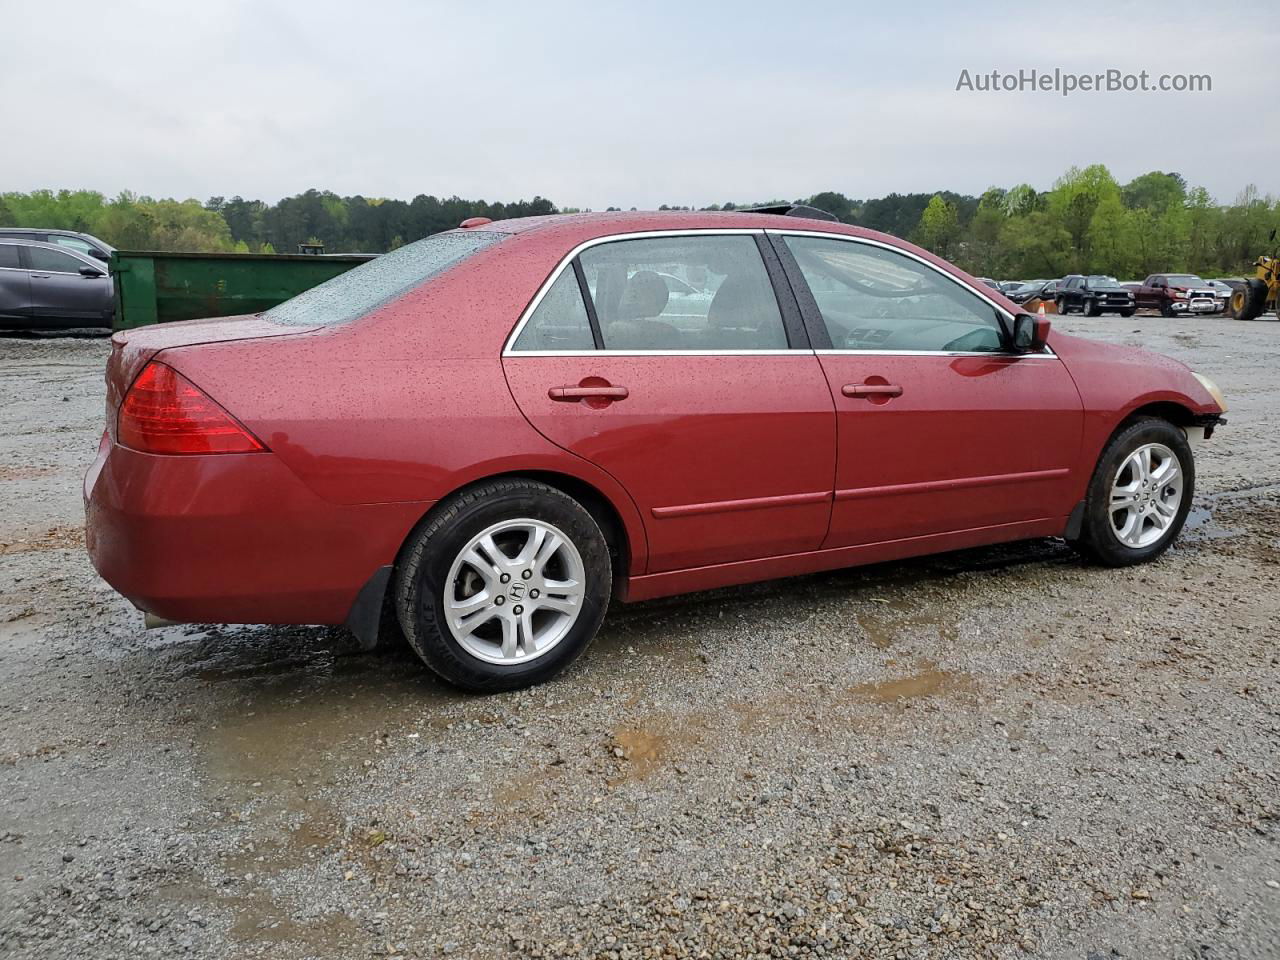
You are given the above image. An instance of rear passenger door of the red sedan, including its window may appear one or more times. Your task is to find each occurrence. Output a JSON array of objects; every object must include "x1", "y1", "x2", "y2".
[{"x1": 503, "y1": 230, "x2": 836, "y2": 572}]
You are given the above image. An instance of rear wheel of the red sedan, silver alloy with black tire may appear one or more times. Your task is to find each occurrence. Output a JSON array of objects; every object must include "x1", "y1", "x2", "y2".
[{"x1": 396, "y1": 479, "x2": 613, "y2": 692}]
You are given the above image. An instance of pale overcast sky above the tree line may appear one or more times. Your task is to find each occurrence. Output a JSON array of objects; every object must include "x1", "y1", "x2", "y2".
[{"x1": 0, "y1": 0, "x2": 1280, "y2": 209}]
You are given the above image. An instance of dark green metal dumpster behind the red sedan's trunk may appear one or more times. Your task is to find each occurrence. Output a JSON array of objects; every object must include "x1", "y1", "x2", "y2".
[{"x1": 111, "y1": 250, "x2": 374, "y2": 330}]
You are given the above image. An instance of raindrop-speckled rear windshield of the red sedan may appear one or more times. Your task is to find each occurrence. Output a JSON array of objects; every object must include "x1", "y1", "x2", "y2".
[{"x1": 262, "y1": 230, "x2": 507, "y2": 326}]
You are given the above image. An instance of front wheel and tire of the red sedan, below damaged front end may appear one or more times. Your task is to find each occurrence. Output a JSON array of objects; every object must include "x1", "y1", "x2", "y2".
[{"x1": 1074, "y1": 417, "x2": 1196, "y2": 567}]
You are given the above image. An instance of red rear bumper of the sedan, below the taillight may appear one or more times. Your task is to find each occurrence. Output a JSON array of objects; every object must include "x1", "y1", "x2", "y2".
[{"x1": 84, "y1": 438, "x2": 431, "y2": 632}]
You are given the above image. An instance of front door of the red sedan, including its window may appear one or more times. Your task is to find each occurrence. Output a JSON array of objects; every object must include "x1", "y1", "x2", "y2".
[{"x1": 776, "y1": 232, "x2": 1083, "y2": 547}]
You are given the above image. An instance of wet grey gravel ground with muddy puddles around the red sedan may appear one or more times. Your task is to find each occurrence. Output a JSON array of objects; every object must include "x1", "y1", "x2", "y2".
[{"x1": 0, "y1": 317, "x2": 1280, "y2": 960}]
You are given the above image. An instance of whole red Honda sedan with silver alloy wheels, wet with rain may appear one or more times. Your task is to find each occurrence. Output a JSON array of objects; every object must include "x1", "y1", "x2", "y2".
[{"x1": 84, "y1": 211, "x2": 1226, "y2": 690}]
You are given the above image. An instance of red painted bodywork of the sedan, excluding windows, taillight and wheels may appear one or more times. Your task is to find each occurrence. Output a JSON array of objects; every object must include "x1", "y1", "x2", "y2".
[{"x1": 84, "y1": 212, "x2": 1216, "y2": 623}]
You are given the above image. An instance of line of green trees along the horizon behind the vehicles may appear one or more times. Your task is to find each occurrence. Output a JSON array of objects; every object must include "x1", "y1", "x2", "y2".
[{"x1": 0, "y1": 164, "x2": 1280, "y2": 279}]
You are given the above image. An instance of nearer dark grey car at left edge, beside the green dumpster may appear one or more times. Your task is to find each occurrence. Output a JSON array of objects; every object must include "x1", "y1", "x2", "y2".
[{"x1": 0, "y1": 236, "x2": 115, "y2": 329}]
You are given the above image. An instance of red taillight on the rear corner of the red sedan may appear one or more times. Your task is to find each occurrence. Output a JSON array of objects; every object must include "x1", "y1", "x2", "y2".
[{"x1": 115, "y1": 361, "x2": 266, "y2": 453}]
